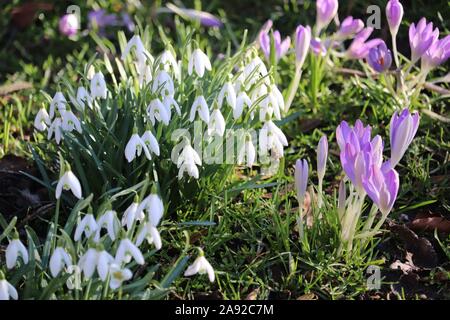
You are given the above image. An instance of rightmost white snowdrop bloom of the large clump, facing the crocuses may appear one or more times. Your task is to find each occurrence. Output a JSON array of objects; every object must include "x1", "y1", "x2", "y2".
[{"x1": 259, "y1": 120, "x2": 288, "y2": 159}]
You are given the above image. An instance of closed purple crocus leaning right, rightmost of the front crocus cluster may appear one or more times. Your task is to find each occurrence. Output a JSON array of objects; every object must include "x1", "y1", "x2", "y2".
[{"x1": 389, "y1": 109, "x2": 420, "y2": 168}]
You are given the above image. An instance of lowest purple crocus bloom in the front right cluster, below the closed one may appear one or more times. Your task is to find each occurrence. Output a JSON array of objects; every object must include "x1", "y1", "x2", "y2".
[{"x1": 363, "y1": 165, "x2": 400, "y2": 216}]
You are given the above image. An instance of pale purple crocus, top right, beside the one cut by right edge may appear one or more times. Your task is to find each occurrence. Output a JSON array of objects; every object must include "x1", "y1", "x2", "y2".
[{"x1": 409, "y1": 18, "x2": 439, "y2": 63}]
